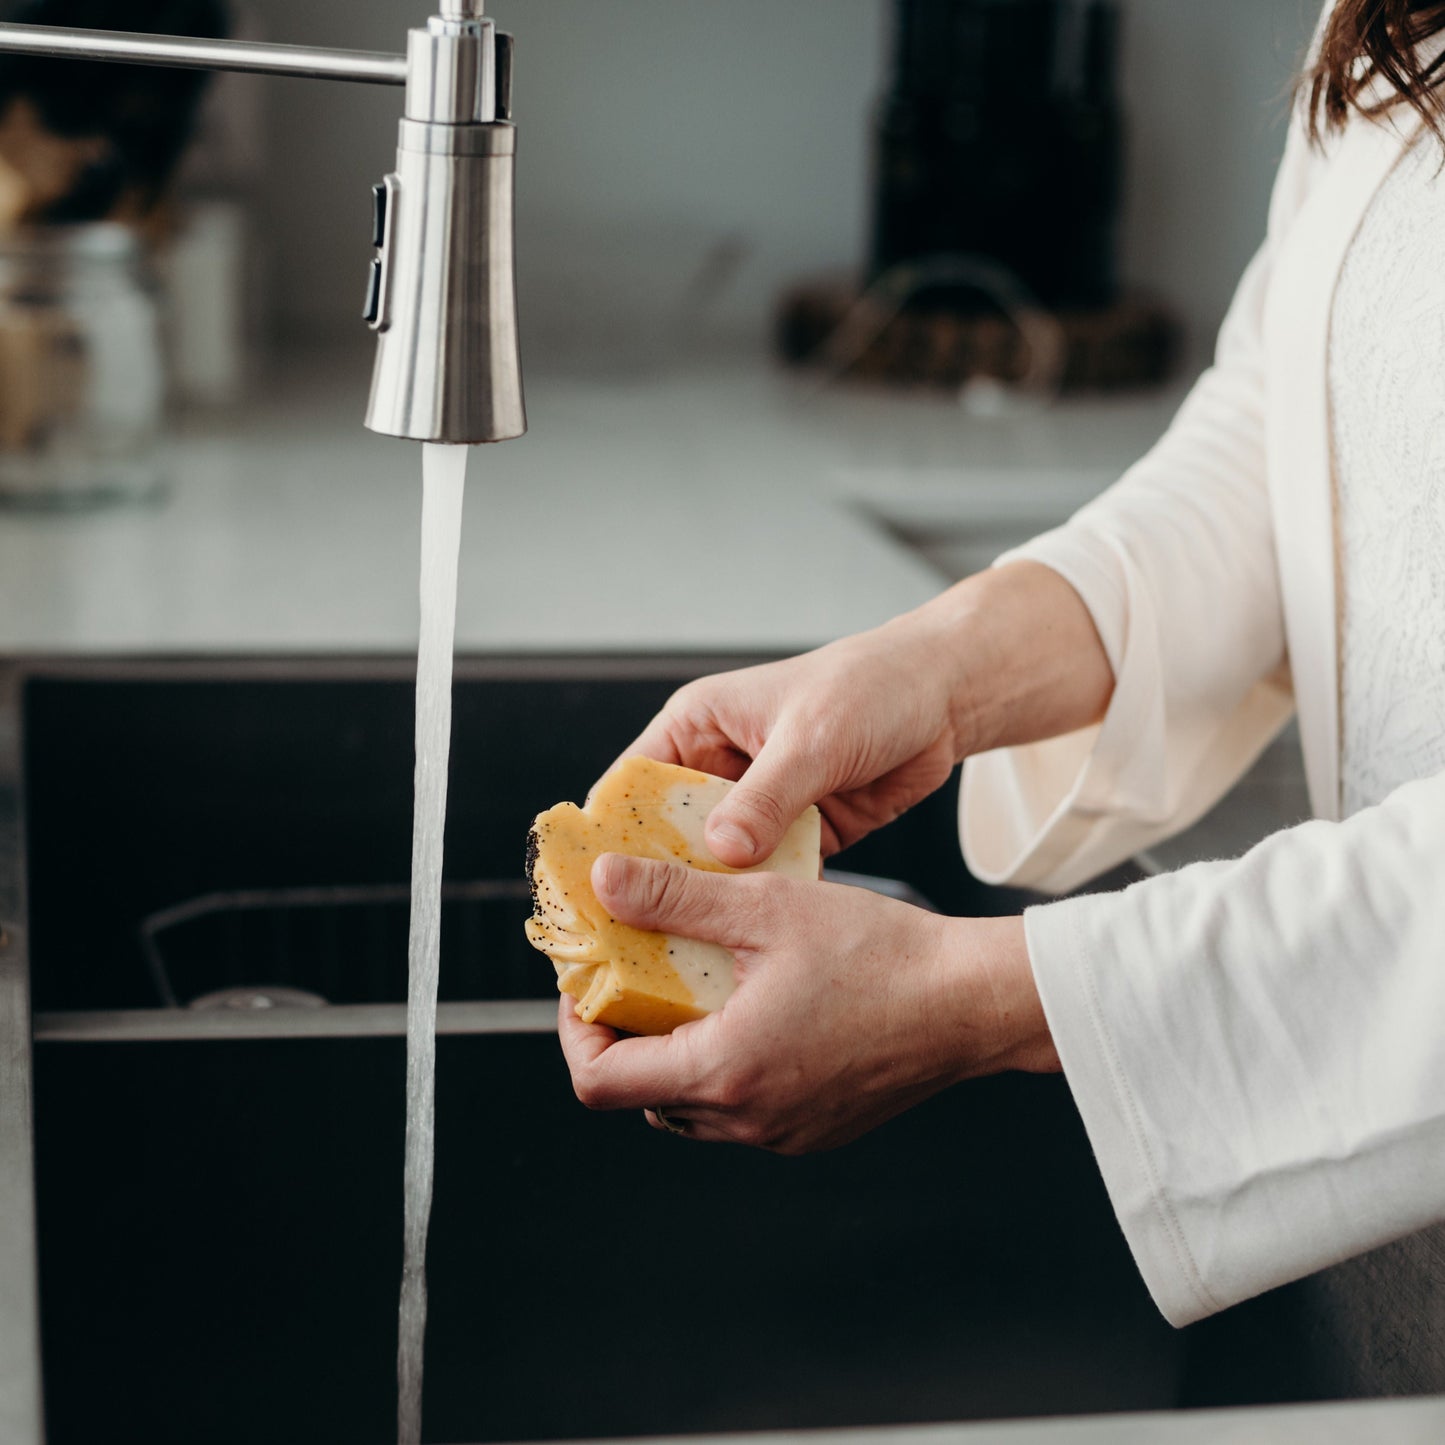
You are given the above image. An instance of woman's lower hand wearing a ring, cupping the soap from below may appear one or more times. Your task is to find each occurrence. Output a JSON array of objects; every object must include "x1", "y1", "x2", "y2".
[{"x1": 559, "y1": 854, "x2": 1059, "y2": 1155}]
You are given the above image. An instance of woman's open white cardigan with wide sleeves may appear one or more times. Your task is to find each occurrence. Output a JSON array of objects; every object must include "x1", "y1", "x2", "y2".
[{"x1": 961, "y1": 36, "x2": 1445, "y2": 1324}]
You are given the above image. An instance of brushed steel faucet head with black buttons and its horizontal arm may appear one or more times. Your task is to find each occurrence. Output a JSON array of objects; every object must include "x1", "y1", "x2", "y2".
[{"x1": 0, "y1": 0, "x2": 527, "y2": 444}]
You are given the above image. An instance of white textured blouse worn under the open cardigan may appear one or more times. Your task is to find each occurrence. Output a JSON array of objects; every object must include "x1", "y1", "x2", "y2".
[{"x1": 1329, "y1": 134, "x2": 1445, "y2": 818}]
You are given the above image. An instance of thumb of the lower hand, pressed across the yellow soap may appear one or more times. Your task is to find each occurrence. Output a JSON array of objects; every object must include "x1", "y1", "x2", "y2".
[{"x1": 592, "y1": 853, "x2": 762, "y2": 948}]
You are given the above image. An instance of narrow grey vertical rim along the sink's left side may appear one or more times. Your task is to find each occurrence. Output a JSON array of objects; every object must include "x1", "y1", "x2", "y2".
[{"x1": 0, "y1": 669, "x2": 43, "y2": 1445}]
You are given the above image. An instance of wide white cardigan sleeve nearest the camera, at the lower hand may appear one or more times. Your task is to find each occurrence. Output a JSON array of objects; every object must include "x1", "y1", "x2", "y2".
[{"x1": 1026, "y1": 775, "x2": 1445, "y2": 1325}]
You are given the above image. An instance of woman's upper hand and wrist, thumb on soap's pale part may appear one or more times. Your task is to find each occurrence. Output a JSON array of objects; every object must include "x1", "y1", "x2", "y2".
[{"x1": 624, "y1": 562, "x2": 1113, "y2": 868}]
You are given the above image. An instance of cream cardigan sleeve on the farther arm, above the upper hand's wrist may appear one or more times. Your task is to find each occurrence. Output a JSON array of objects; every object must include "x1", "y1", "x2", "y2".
[{"x1": 959, "y1": 124, "x2": 1318, "y2": 893}]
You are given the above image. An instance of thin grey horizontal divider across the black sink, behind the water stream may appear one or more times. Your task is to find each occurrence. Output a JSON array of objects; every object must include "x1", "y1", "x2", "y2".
[{"x1": 35, "y1": 998, "x2": 556, "y2": 1040}]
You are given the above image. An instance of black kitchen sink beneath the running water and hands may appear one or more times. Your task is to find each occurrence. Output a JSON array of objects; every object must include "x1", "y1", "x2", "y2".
[{"x1": 0, "y1": 657, "x2": 1306, "y2": 1445}]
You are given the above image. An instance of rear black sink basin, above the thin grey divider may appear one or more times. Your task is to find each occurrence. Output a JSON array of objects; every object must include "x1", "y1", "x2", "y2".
[{"x1": 23, "y1": 659, "x2": 988, "y2": 1013}]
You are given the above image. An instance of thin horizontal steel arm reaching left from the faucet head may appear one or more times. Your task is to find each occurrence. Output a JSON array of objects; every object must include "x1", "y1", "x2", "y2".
[{"x1": 0, "y1": 25, "x2": 406, "y2": 85}]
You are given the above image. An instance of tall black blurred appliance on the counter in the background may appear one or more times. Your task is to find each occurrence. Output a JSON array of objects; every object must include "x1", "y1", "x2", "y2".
[{"x1": 868, "y1": 0, "x2": 1123, "y2": 311}]
